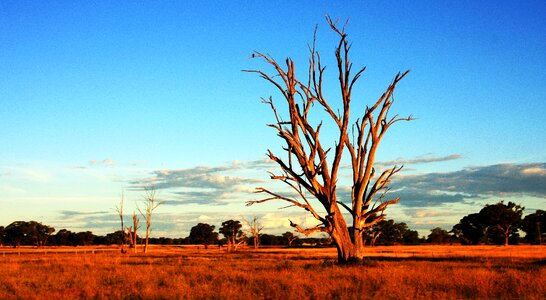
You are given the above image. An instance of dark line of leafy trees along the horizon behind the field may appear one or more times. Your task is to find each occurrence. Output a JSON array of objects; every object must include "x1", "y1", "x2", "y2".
[{"x1": 0, "y1": 201, "x2": 546, "y2": 251}]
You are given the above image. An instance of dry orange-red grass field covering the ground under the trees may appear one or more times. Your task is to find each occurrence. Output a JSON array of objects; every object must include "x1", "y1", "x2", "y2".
[{"x1": 0, "y1": 246, "x2": 546, "y2": 299}]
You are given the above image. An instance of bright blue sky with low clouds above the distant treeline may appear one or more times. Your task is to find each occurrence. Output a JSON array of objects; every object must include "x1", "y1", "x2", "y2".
[{"x1": 0, "y1": 1, "x2": 546, "y2": 236}]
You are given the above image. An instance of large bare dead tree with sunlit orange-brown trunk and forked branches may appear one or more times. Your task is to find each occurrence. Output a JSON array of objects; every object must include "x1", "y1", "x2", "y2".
[{"x1": 245, "y1": 17, "x2": 412, "y2": 263}]
